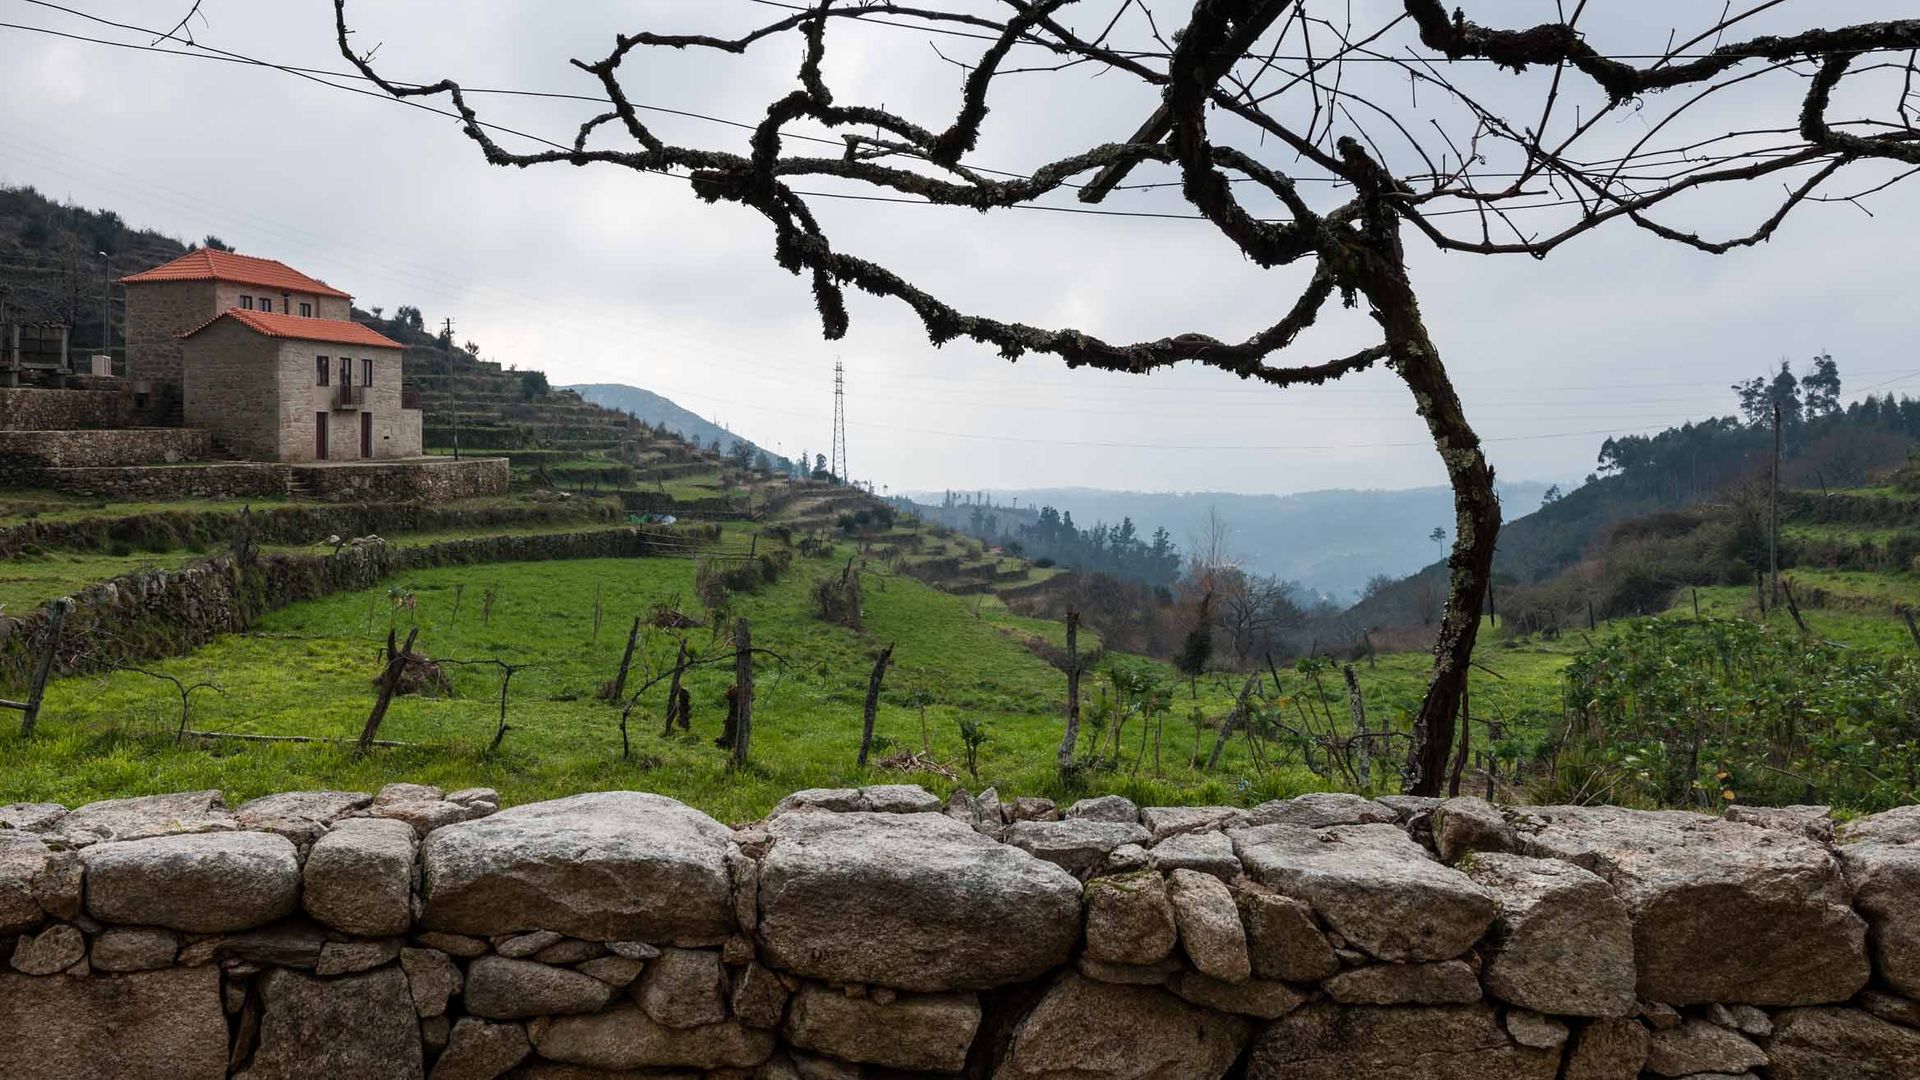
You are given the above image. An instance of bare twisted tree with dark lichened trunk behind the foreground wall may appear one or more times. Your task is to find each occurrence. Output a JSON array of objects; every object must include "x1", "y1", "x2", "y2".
[{"x1": 334, "y1": 0, "x2": 1920, "y2": 794}]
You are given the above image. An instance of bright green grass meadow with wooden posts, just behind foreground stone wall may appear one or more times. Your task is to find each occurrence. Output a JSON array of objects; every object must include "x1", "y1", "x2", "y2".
[{"x1": 0, "y1": 541, "x2": 1419, "y2": 821}]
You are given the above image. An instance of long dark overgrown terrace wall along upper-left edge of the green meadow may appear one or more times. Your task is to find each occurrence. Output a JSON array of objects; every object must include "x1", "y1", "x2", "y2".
[{"x1": 0, "y1": 525, "x2": 714, "y2": 672}]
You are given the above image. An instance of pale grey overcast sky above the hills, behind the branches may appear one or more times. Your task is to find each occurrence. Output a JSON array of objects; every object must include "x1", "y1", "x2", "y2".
[{"x1": 0, "y1": 0, "x2": 1920, "y2": 492}]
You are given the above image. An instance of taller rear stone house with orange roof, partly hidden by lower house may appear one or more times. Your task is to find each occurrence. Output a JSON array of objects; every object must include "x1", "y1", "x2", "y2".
[{"x1": 119, "y1": 248, "x2": 355, "y2": 423}]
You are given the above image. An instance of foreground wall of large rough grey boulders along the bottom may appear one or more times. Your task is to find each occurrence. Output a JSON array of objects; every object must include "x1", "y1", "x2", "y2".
[{"x1": 0, "y1": 784, "x2": 1920, "y2": 1080}]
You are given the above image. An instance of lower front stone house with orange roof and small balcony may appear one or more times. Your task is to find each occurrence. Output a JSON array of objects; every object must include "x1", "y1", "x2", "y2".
[{"x1": 179, "y1": 311, "x2": 420, "y2": 461}]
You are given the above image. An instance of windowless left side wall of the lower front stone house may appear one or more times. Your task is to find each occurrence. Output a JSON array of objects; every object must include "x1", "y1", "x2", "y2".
[{"x1": 180, "y1": 319, "x2": 284, "y2": 461}]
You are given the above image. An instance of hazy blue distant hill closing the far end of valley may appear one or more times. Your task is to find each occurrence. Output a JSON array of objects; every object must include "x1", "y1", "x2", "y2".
[{"x1": 914, "y1": 482, "x2": 1548, "y2": 601}]
